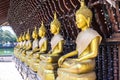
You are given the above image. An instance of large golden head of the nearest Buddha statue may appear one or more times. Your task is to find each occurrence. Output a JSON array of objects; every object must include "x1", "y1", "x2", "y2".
[{"x1": 75, "y1": 0, "x2": 92, "y2": 29}]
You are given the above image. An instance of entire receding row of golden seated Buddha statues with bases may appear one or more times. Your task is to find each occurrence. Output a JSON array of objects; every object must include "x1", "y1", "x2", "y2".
[{"x1": 14, "y1": 0, "x2": 102, "y2": 80}]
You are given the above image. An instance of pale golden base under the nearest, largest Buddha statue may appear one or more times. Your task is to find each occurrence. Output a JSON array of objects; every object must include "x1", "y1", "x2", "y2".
[{"x1": 56, "y1": 70, "x2": 96, "y2": 80}]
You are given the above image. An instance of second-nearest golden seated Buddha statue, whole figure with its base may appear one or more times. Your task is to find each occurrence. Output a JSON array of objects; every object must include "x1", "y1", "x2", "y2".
[{"x1": 38, "y1": 13, "x2": 64, "y2": 80}]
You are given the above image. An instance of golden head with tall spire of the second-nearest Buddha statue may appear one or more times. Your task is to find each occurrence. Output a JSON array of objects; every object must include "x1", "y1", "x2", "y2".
[{"x1": 50, "y1": 13, "x2": 61, "y2": 34}]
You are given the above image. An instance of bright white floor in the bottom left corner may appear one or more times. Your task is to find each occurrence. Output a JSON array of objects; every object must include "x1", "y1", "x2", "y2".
[{"x1": 0, "y1": 62, "x2": 23, "y2": 80}]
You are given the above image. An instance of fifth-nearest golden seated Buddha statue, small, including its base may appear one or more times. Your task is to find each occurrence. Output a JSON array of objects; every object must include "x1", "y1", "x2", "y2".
[{"x1": 21, "y1": 29, "x2": 32, "y2": 62}]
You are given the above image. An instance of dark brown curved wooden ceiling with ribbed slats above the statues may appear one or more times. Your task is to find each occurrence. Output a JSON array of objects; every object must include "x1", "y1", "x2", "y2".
[{"x1": 0, "y1": 0, "x2": 120, "y2": 40}]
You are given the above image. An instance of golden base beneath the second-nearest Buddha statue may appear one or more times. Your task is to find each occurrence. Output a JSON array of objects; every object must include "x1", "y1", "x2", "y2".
[{"x1": 37, "y1": 61, "x2": 58, "y2": 80}]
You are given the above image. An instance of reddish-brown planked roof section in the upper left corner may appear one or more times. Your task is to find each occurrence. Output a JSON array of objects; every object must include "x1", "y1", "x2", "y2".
[{"x1": 0, "y1": 0, "x2": 10, "y2": 25}]
